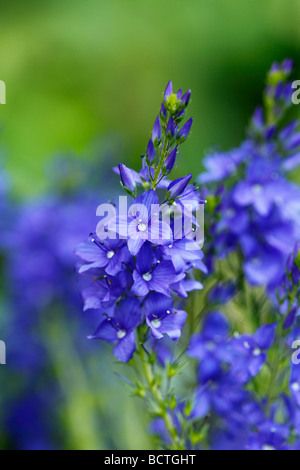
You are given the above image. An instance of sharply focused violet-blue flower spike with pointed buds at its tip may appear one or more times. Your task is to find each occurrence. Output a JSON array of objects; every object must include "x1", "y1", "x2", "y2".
[{"x1": 76, "y1": 82, "x2": 206, "y2": 362}]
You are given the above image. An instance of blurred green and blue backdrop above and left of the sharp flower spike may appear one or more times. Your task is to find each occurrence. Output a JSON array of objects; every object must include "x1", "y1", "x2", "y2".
[{"x1": 0, "y1": 0, "x2": 300, "y2": 449}]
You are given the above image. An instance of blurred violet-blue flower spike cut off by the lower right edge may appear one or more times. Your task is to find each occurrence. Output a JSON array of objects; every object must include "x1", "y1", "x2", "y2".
[{"x1": 240, "y1": 244, "x2": 300, "y2": 450}]
